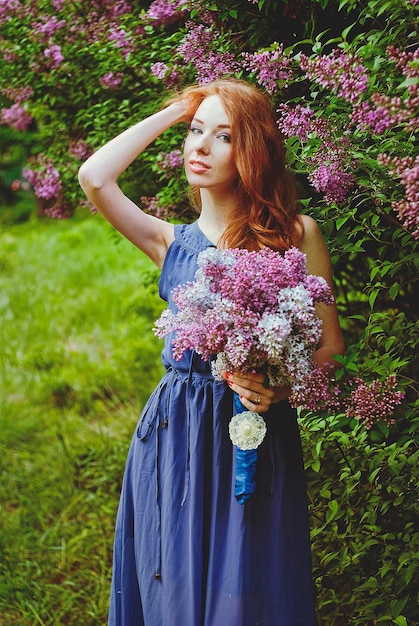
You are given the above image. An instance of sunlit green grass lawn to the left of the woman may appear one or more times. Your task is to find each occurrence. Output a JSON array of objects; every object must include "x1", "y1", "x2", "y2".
[{"x1": 0, "y1": 216, "x2": 167, "y2": 626}]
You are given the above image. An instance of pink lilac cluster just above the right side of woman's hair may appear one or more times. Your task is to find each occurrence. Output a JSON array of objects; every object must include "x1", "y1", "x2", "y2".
[{"x1": 242, "y1": 44, "x2": 293, "y2": 94}]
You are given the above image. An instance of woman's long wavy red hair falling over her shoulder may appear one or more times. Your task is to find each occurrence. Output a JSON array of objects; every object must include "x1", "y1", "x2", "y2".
[{"x1": 169, "y1": 79, "x2": 302, "y2": 252}]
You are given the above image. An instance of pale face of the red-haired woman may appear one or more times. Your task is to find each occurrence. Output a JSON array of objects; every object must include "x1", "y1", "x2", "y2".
[{"x1": 184, "y1": 96, "x2": 238, "y2": 189}]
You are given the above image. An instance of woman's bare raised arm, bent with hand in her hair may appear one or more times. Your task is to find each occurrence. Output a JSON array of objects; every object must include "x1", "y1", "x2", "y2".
[{"x1": 79, "y1": 100, "x2": 187, "y2": 267}]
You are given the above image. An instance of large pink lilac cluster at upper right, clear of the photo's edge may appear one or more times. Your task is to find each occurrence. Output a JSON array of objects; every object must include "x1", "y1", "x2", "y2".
[{"x1": 300, "y1": 50, "x2": 369, "y2": 103}]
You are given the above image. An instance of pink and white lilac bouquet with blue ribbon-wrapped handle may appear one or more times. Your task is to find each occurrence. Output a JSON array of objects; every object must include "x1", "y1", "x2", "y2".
[{"x1": 154, "y1": 248, "x2": 333, "y2": 504}]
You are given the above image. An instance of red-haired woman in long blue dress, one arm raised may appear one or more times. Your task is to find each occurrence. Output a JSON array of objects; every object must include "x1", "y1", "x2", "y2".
[{"x1": 79, "y1": 80, "x2": 344, "y2": 626}]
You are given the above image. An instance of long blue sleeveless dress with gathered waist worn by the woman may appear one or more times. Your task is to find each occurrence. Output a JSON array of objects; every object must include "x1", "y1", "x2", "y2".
[{"x1": 109, "y1": 222, "x2": 315, "y2": 626}]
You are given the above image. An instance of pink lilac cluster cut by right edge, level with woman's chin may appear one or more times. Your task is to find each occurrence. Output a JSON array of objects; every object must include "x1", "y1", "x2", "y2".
[{"x1": 377, "y1": 154, "x2": 419, "y2": 239}]
